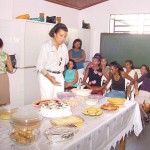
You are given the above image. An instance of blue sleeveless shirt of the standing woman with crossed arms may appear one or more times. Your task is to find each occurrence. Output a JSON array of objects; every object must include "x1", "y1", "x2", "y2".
[{"x1": 72, "y1": 49, "x2": 84, "y2": 69}]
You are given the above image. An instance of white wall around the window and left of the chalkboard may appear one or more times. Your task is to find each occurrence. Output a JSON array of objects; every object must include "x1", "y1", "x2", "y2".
[{"x1": 79, "y1": 0, "x2": 150, "y2": 54}]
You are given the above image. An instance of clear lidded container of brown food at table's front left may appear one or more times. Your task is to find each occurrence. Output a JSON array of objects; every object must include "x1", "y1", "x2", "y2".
[{"x1": 9, "y1": 110, "x2": 42, "y2": 145}]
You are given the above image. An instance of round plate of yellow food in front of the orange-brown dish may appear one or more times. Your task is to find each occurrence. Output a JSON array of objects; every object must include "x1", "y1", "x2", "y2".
[{"x1": 82, "y1": 106, "x2": 103, "y2": 116}]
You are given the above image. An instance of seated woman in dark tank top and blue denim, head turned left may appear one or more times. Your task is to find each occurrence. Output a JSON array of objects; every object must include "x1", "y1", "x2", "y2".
[{"x1": 102, "y1": 61, "x2": 134, "y2": 98}]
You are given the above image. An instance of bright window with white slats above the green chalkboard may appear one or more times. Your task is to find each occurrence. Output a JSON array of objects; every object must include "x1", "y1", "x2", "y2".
[{"x1": 110, "y1": 14, "x2": 150, "y2": 34}]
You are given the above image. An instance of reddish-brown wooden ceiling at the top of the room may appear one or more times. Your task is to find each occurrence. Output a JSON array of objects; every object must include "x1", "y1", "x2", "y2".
[{"x1": 46, "y1": 0, "x2": 108, "y2": 10}]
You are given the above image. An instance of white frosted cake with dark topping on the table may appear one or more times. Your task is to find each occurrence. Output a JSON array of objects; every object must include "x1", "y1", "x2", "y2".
[{"x1": 40, "y1": 100, "x2": 72, "y2": 118}]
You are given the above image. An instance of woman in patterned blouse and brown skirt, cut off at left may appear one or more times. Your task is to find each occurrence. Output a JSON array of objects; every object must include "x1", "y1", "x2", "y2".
[{"x1": 0, "y1": 38, "x2": 13, "y2": 105}]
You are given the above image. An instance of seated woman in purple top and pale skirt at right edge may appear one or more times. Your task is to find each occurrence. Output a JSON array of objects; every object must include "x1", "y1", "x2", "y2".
[{"x1": 135, "y1": 72, "x2": 150, "y2": 119}]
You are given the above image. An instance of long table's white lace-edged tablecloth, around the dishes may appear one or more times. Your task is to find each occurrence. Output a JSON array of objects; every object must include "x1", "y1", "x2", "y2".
[{"x1": 0, "y1": 98, "x2": 142, "y2": 150}]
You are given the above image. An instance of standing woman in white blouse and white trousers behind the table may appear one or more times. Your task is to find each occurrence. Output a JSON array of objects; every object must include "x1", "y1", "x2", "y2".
[{"x1": 36, "y1": 23, "x2": 69, "y2": 99}]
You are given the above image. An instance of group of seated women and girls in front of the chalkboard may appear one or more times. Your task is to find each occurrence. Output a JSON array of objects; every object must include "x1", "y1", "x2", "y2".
[{"x1": 64, "y1": 54, "x2": 150, "y2": 122}]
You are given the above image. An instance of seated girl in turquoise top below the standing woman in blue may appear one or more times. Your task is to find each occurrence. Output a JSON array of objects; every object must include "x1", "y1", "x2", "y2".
[{"x1": 64, "y1": 59, "x2": 78, "y2": 91}]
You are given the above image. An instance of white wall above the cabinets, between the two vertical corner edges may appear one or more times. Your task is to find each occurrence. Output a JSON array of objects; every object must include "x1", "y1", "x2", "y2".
[{"x1": 13, "y1": 0, "x2": 79, "y2": 27}]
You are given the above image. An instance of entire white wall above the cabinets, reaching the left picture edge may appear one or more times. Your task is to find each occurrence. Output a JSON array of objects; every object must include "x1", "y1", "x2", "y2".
[{"x1": 0, "y1": 0, "x2": 79, "y2": 27}]
